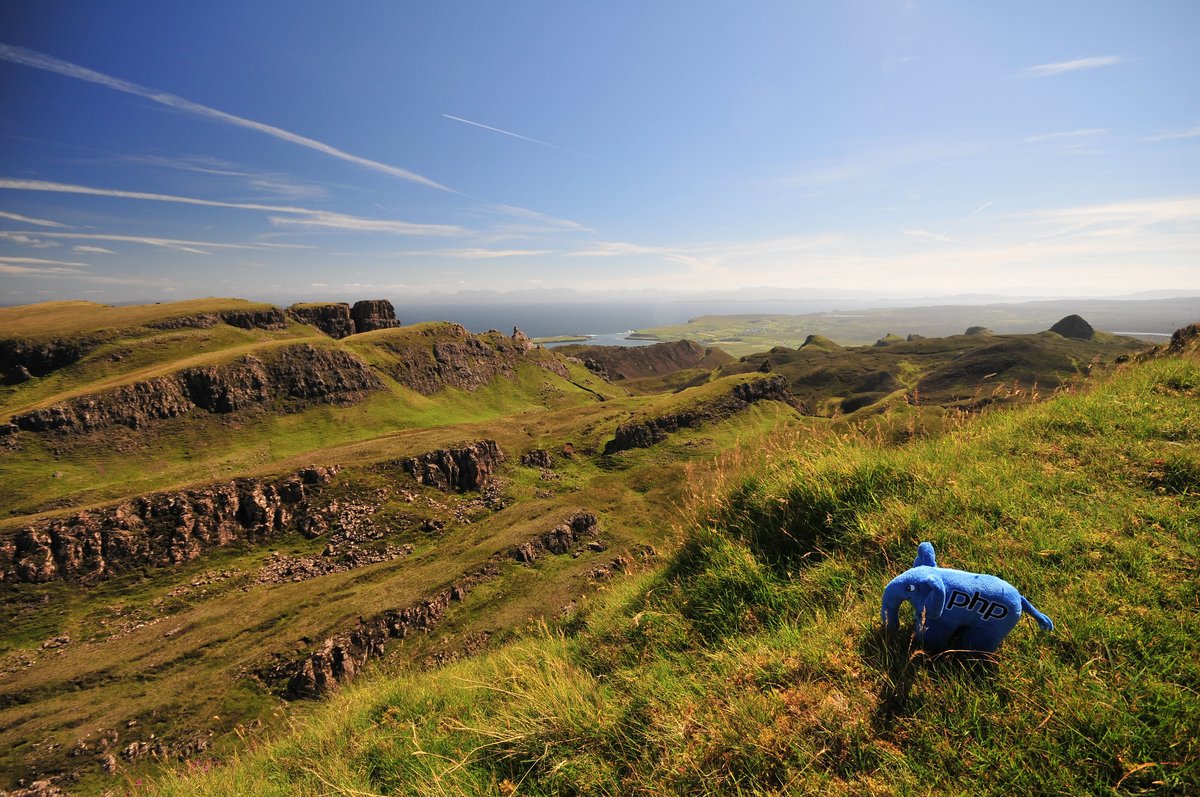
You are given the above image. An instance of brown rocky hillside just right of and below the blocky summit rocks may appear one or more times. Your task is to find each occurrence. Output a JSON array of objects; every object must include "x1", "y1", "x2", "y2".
[{"x1": 378, "y1": 324, "x2": 569, "y2": 396}]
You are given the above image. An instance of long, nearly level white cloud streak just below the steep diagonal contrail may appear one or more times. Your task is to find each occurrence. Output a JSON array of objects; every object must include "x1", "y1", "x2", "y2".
[{"x1": 0, "y1": 178, "x2": 467, "y2": 238}]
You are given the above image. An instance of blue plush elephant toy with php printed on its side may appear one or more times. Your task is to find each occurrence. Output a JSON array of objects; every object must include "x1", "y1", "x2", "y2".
[{"x1": 882, "y1": 543, "x2": 1054, "y2": 653}]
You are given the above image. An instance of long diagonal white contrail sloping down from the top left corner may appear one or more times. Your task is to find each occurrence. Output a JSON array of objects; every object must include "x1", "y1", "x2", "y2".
[{"x1": 0, "y1": 44, "x2": 450, "y2": 191}]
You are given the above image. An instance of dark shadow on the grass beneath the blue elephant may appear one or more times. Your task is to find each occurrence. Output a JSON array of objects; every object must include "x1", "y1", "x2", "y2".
[{"x1": 859, "y1": 625, "x2": 1000, "y2": 731}]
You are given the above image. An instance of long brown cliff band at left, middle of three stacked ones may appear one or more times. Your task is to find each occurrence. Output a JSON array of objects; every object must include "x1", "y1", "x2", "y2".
[{"x1": 8, "y1": 343, "x2": 382, "y2": 433}]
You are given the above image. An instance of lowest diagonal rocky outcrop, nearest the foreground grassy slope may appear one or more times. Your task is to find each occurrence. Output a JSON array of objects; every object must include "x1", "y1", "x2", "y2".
[{"x1": 267, "y1": 511, "x2": 599, "y2": 697}]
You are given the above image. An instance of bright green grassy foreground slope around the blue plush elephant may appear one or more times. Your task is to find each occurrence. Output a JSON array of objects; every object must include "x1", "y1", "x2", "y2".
[{"x1": 151, "y1": 355, "x2": 1200, "y2": 795}]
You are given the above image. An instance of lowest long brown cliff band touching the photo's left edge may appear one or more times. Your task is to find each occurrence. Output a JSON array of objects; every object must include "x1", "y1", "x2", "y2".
[{"x1": 0, "y1": 467, "x2": 337, "y2": 582}]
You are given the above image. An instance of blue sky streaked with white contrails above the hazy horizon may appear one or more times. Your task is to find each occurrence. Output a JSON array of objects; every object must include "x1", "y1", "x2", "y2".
[{"x1": 0, "y1": 0, "x2": 1200, "y2": 302}]
